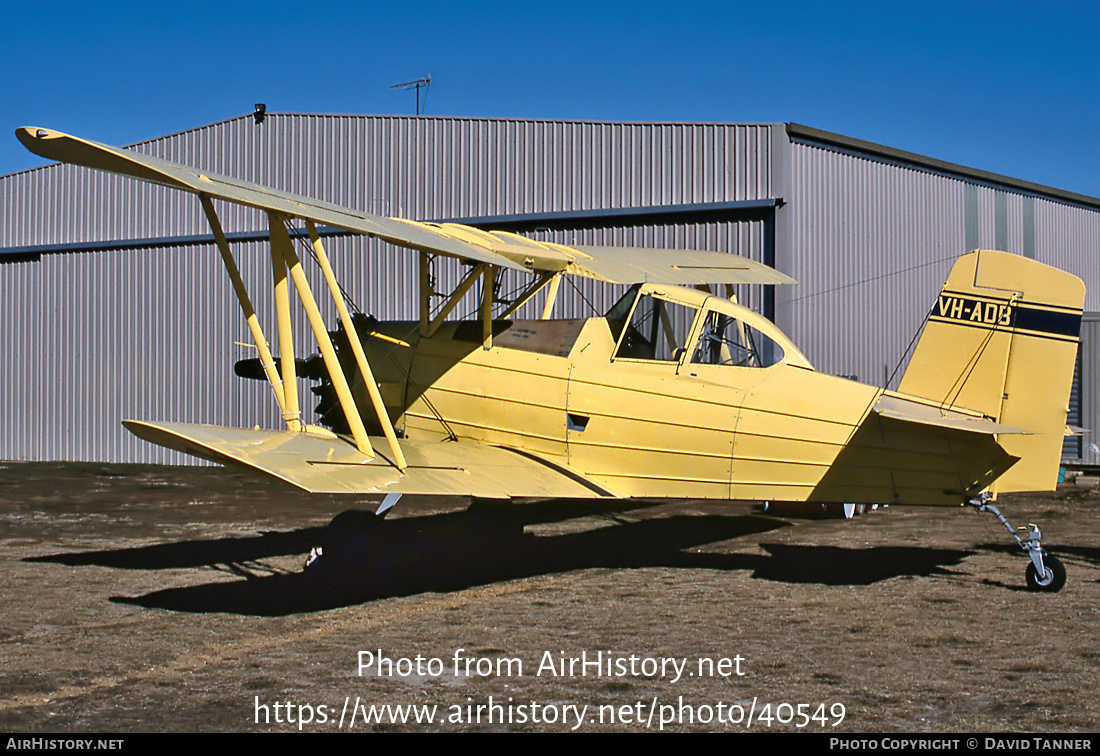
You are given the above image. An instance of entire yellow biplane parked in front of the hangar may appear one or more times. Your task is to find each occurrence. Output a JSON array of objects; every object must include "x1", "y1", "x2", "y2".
[{"x1": 17, "y1": 128, "x2": 1085, "y2": 591}]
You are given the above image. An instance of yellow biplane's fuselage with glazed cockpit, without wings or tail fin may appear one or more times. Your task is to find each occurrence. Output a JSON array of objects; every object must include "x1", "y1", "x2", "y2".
[{"x1": 327, "y1": 286, "x2": 996, "y2": 504}]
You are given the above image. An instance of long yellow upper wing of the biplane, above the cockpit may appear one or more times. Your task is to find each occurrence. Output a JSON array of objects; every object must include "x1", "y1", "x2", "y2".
[{"x1": 15, "y1": 128, "x2": 794, "y2": 285}]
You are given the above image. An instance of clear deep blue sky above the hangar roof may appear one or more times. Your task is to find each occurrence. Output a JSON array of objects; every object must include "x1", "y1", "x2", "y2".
[{"x1": 8, "y1": 0, "x2": 1100, "y2": 196}]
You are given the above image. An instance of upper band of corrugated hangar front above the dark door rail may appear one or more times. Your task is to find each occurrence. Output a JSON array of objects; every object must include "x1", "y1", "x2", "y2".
[{"x1": 0, "y1": 113, "x2": 782, "y2": 248}]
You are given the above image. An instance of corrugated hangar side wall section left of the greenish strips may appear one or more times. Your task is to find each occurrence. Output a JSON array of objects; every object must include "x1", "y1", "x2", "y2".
[{"x1": 776, "y1": 143, "x2": 965, "y2": 388}]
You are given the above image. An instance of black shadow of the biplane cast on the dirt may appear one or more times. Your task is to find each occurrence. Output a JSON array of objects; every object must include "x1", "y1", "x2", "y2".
[{"x1": 31, "y1": 501, "x2": 971, "y2": 616}]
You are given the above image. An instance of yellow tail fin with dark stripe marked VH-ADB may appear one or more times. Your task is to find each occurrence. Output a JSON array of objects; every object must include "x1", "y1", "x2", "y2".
[{"x1": 898, "y1": 250, "x2": 1085, "y2": 493}]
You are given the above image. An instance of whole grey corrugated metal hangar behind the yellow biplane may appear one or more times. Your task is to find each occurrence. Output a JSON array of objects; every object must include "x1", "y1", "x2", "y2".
[{"x1": 0, "y1": 113, "x2": 1100, "y2": 464}]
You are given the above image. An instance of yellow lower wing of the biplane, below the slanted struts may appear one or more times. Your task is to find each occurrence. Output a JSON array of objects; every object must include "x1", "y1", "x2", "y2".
[{"x1": 123, "y1": 420, "x2": 618, "y2": 498}]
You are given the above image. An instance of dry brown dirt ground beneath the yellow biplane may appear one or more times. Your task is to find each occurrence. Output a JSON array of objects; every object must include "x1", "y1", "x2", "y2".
[{"x1": 0, "y1": 463, "x2": 1100, "y2": 733}]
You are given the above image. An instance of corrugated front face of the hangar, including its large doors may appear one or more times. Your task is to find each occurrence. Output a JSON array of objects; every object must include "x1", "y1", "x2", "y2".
[{"x1": 0, "y1": 113, "x2": 782, "y2": 464}]
